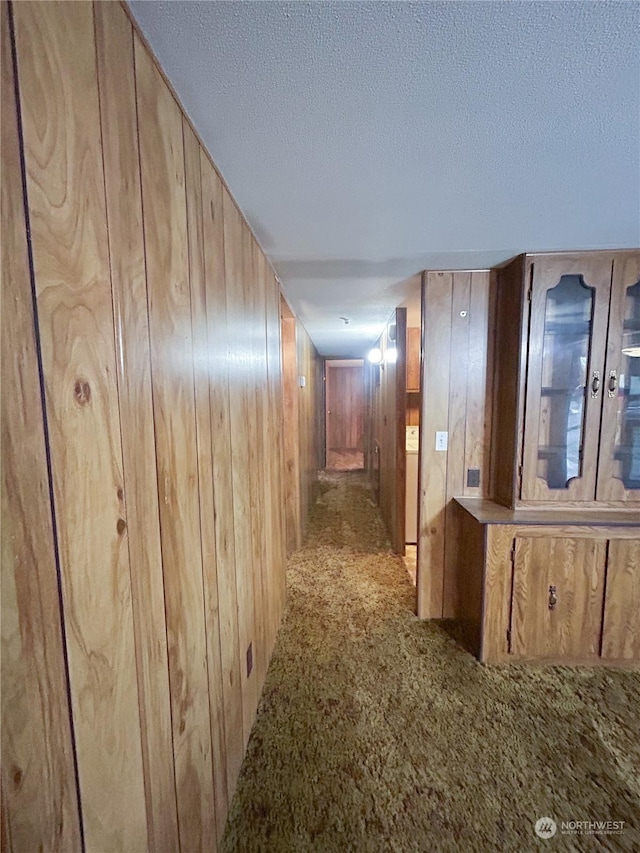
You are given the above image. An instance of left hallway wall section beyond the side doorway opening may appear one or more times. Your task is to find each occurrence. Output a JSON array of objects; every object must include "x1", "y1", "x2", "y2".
[{"x1": 280, "y1": 297, "x2": 324, "y2": 554}]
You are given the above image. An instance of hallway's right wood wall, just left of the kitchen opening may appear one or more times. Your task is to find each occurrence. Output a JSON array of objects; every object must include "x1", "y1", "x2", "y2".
[{"x1": 364, "y1": 308, "x2": 407, "y2": 554}]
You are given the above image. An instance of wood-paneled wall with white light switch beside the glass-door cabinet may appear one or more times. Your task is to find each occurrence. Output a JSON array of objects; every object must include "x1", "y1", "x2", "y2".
[{"x1": 417, "y1": 271, "x2": 495, "y2": 619}]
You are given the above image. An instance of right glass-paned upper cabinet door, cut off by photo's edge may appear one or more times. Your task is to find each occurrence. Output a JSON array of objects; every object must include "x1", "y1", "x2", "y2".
[{"x1": 597, "y1": 252, "x2": 640, "y2": 502}]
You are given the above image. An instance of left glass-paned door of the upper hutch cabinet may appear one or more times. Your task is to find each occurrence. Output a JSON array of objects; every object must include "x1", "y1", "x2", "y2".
[{"x1": 521, "y1": 254, "x2": 613, "y2": 501}]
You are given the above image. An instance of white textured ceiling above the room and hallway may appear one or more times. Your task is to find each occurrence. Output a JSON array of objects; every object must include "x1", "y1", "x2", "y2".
[{"x1": 130, "y1": 0, "x2": 640, "y2": 356}]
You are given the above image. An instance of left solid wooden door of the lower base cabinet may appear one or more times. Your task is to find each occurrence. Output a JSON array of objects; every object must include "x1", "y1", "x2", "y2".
[{"x1": 509, "y1": 534, "x2": 607, "y2": 659}]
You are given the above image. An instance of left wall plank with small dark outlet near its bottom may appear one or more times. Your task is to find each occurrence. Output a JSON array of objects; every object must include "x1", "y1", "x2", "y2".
[{"x1": 222, "y1": 185, "x2": 258, "y2": 746}]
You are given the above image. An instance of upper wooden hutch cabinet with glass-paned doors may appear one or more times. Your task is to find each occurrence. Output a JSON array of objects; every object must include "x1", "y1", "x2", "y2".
[{"x1": 493, "y1": 252, "x2": 640, "y2": 507}]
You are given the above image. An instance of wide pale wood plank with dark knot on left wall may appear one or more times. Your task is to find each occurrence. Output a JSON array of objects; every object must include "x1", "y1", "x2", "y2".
[{"x1": 14, "y1": 3, "x2": 148, "y2": 851}]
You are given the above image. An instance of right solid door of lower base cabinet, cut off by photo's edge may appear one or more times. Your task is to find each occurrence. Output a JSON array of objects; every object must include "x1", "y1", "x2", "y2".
[{"x1": 602, "y1": 539, "x2": 640, "y2": 661}]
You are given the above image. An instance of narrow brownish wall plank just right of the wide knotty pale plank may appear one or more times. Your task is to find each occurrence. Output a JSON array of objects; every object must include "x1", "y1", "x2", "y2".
[{"x1": 94, "y1": 3, "x2": 178, "y2": 851}]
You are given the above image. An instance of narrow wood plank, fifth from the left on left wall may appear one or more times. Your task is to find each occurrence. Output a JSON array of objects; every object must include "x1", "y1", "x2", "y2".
[{"x1": 183, "y1": 118, "x2": 229, "y2": 839}]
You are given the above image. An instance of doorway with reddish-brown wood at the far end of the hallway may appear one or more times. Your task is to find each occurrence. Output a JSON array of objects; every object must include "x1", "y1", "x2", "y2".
[{"x1": 325, "y1": 359, "x2": 364, "y2": 471}]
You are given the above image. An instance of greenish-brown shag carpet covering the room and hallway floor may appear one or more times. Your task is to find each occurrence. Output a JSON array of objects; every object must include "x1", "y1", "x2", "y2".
[{"x1": 222, "y1": 474, "x2": 640, "y2": 853}]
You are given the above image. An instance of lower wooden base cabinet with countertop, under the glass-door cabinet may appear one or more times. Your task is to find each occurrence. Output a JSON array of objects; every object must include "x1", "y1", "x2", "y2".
[{"x1": 457, "y1": 498, "x2": 640, "y2": 664}]
